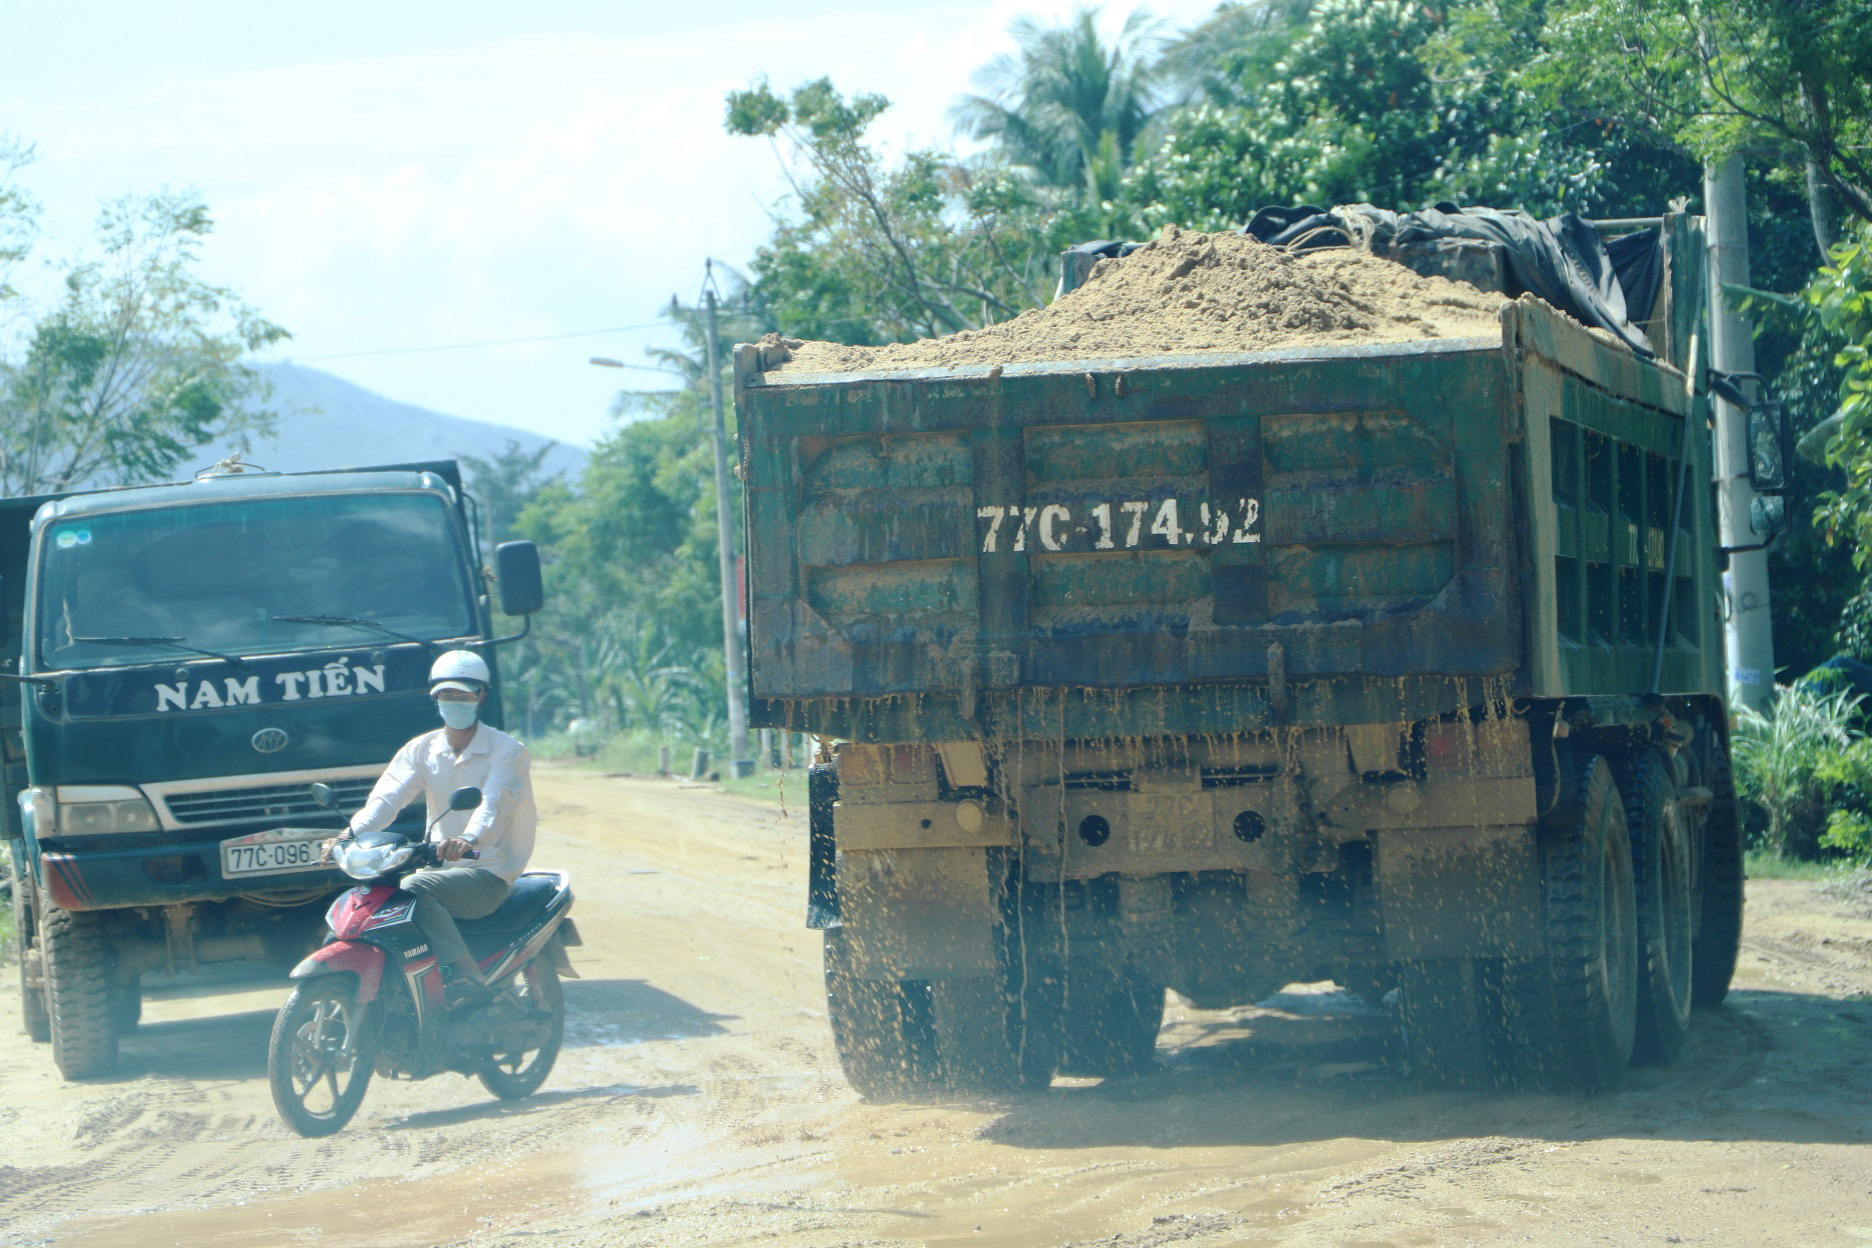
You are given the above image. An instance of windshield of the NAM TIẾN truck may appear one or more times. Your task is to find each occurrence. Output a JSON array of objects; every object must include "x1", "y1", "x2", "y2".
[{"x1": 36, "y1": 494, "x2": 475, "y2": 670}]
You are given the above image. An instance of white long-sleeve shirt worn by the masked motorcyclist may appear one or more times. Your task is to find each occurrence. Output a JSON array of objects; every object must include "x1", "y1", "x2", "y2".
[{"x1": 352, "y1": 724, "x2": 539, "y2": 883}]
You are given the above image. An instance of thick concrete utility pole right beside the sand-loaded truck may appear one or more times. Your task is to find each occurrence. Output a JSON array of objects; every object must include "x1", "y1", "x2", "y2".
[{"x1": 1704, "y1": 155, "x2": 1775, "y2": 711}]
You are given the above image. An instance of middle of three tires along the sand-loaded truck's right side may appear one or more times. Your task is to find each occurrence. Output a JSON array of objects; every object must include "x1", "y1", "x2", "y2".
[{"x1": 1623, "y1": 748, "x2": 1696, "y2": 1065}]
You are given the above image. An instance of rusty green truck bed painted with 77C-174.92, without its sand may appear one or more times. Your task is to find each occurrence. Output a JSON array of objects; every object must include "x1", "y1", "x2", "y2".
[{"x1": 736, "y1": 299, "x2": 1709, "y2": 741}]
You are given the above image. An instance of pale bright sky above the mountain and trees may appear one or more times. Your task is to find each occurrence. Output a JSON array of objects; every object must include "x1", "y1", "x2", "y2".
[{"x1": 0, "y1": 0, "x2": 1215, "y2": 443}]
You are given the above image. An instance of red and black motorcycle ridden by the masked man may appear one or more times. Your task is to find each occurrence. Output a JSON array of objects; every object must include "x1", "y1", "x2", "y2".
[{"x1": 266, "y1": 784, "x2": 580, "y2": 1136}]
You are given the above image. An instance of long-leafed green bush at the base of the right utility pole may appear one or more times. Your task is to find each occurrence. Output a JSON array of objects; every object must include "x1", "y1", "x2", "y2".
[{"x1": 1733, "y1": 679, "x2": 1872, "y2": 859}]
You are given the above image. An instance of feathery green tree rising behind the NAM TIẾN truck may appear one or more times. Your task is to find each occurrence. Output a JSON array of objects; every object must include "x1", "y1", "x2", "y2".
[{"x1": 0, "y1": 193, "x2": 288, "y2": 494}]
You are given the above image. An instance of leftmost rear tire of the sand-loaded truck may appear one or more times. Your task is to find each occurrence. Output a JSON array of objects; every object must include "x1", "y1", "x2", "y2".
[{"x1": 826, "y1": 928, "x2": 936, "y2": 1100}]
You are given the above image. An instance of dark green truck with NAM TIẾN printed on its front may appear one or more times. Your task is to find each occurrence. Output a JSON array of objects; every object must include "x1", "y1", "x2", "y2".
[{"x1": 0, "y1": 460, "x2": 541, "y2": 1078}]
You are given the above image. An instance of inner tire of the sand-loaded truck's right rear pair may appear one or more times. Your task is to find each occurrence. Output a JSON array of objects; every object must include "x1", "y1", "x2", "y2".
[{"x1": 1398, "y1": 958, "x2": 1509, "y2": 1089}]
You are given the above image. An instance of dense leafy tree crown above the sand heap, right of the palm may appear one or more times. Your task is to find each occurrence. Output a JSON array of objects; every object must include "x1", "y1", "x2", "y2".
[{"x1": 1129, "y1": 0, "x2": 1696, "y2": 228}]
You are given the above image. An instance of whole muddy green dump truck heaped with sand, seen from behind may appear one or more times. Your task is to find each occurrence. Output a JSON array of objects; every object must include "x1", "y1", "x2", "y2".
[{"x1": 734, "y1": 213, "x2": 1741, "y2": 1096}]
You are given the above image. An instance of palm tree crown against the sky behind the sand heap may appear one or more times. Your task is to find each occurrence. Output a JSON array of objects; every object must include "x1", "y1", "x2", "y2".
[{"x1": 951, "y1": 9, "x2": 1159, "y2": 200}]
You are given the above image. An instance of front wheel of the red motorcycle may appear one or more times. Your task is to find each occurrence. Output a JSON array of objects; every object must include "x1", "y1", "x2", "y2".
[{"x1": 266, "y1": 975, "x2": 371, "y2": 1136}]
